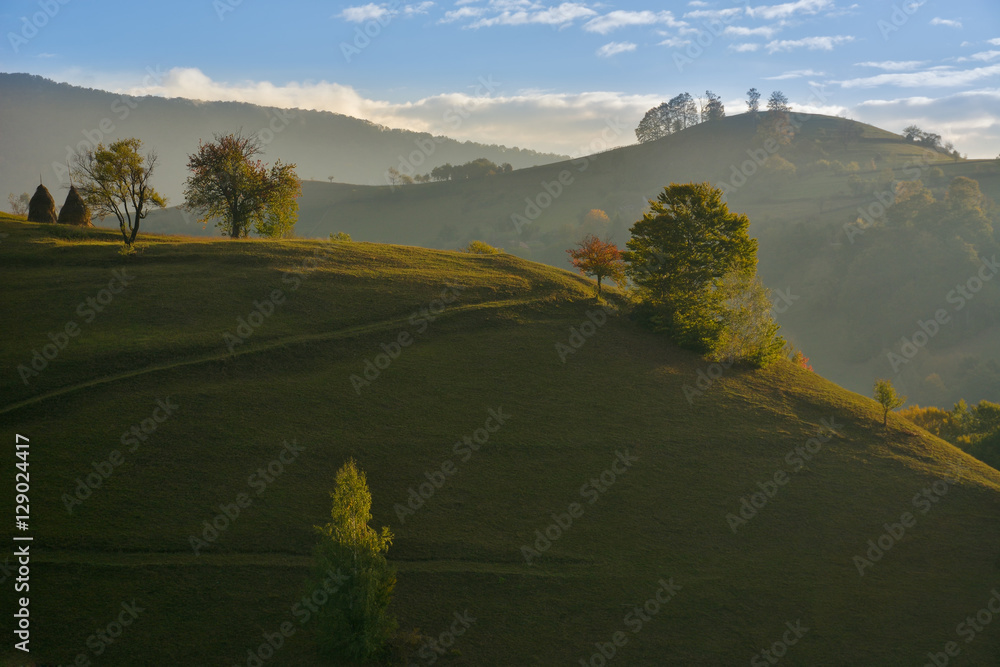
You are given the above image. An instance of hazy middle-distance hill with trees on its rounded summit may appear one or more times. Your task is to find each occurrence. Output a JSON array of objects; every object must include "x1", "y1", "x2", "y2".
[{"x1": 141, "y1": 115, "x2": 1000, "y2": 407}]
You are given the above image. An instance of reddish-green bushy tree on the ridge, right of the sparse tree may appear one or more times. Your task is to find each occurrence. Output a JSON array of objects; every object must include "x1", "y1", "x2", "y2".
[{"x1": 184, "y1": 130, "x2": 302, "y2": 239}]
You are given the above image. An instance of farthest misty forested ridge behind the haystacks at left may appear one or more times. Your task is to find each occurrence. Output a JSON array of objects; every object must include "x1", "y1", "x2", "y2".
[{"x1": 0, "y1": 73, "x2": 561, "y2": 204}]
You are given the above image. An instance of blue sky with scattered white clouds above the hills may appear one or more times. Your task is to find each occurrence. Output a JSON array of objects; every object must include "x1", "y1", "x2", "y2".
[{"x1": 0, "y1": 0, "x2": 1000, "y2": 158}]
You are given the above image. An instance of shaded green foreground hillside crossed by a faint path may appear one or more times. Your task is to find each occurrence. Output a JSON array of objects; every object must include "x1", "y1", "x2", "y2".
[{"x1": 0, "y1": 221, "x2": 1000, "y2": 666}]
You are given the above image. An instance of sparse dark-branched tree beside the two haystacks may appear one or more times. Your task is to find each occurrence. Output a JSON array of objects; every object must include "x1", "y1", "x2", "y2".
[{"x1": 71, "y1": 137, "x2": 167, "y2": 247}]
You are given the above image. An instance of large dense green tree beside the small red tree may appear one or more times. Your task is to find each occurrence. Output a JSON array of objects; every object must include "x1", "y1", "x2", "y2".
[{"x1": 625, "y1": 183, "x2": 757, "y2": 353}]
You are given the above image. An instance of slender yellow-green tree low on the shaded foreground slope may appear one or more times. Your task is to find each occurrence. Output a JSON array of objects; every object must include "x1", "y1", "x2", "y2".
[{"x1": 310, "y1": 459, "x2": 396, "y2": 660}]
